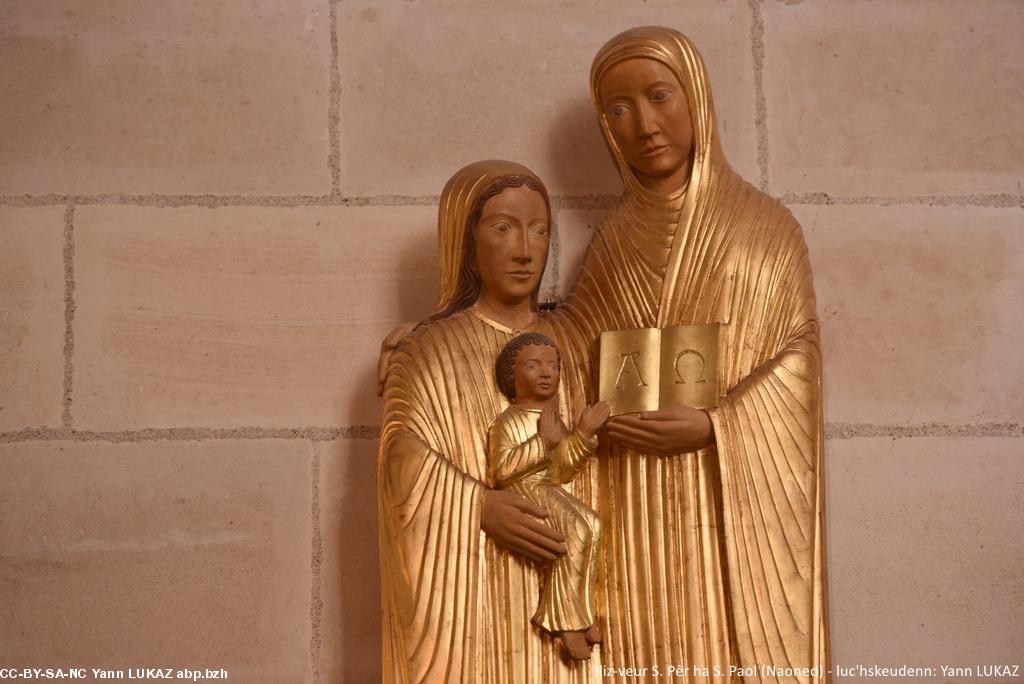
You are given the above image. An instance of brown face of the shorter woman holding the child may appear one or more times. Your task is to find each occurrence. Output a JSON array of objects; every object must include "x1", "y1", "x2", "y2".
[{"x1": 476, "y1": 185, "x2": 551, "y2": 304}]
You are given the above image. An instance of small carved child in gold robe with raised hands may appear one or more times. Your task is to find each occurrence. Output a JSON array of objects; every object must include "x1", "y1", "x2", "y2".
[{"x1": 487, "y1": 333, "x2": 609, "y2": 660}]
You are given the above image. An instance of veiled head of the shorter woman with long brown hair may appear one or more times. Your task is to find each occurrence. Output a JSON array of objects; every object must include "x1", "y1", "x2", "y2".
[{"x1": 435, "y1": 160, "x2": 551, "y2": 317}]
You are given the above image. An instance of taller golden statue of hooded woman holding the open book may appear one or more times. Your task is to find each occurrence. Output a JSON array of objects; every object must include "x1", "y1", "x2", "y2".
[{"x1": 557, "y1": 27, "x2": 828, "y2": 682}]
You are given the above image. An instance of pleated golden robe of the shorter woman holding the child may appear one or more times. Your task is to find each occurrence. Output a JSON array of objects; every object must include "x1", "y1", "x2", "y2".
[{"x1": 378, "y1": 311, "x2": 600, "y2": 684}]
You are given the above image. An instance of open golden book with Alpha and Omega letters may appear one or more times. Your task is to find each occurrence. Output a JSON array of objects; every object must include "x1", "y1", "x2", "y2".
[{"x1": 598, "y1": 324, "x2": 720, "y2": 416}]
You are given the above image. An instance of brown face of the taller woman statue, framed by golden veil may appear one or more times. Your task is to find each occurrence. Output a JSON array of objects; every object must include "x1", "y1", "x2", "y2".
[{"x1": 599, "y1": 57, "x2": 693, "y2": 195}]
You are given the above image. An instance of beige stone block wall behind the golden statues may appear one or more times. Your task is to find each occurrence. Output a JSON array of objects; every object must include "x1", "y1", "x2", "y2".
[{"x1": 0, "y1": 0, "x2": 1024, "y2": 682}]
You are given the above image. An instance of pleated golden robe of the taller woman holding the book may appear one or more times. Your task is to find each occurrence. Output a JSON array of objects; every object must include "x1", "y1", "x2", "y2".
[{"x1": 555, "y1": 169, "x2": 826, "y2": 682}]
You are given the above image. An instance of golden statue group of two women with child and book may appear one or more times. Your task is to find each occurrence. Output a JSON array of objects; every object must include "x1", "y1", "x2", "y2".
[{"x1": 378, "y1": 27, "x2": 829, "y2": 684}]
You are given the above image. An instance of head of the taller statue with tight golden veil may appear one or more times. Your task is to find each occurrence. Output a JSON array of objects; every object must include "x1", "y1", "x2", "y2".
[{"x1": 591, "y1": 27, "x2": 721, "y2": 195}]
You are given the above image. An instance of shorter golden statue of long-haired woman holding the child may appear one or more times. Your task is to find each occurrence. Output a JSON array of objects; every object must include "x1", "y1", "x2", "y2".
[{"x1": 378, "y1": 161, "x2": 592, "y2": 682}]
